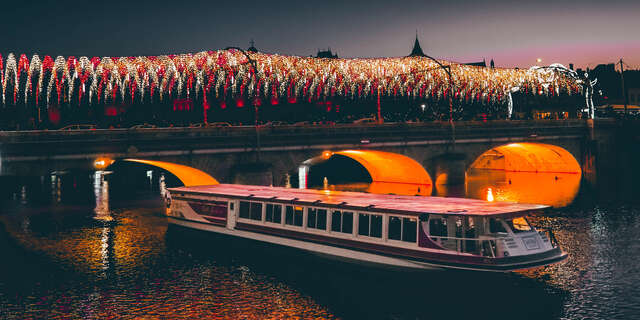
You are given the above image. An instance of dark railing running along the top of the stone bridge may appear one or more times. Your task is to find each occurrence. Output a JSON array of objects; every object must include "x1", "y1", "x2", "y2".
[{"x1": 0, "y1": 120, "x2": 587, "y2": 161}]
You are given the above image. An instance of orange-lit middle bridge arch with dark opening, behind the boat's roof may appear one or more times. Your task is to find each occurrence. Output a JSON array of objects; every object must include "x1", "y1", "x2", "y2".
[{"x1": 298, "y1": 150, "x2": 433, "y2": 195}]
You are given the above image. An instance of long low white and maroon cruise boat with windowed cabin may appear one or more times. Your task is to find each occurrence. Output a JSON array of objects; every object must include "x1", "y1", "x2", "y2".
[{"x1": 167, "y1": 184, "x2": 567, "y2": 271}]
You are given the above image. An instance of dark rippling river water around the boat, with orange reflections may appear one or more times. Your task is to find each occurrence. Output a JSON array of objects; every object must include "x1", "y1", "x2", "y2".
[{"x1": 0, "y1": 171, "x2": 640, "y2": 319}]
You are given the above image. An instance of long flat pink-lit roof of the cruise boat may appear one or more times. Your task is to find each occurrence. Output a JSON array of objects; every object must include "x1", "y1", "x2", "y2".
[{"x1": 169, "y1": 184, "x2": 548, "y2": 216}]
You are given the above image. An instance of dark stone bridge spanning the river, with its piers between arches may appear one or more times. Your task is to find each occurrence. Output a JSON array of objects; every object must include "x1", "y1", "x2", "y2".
[{"x1": 0, "y1": 120, "x2": 619, "y2": 185}]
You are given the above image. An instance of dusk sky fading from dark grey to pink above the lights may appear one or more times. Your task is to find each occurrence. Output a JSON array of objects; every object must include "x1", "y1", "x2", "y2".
[{"x1": 0, "y1": 0, "x2": 640, "y2": 68}]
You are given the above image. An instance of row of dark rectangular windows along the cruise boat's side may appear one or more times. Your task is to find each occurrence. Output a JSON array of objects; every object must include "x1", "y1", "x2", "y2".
[{"x1": 239, "y1": 201, "x2": 417, "y2": 242}]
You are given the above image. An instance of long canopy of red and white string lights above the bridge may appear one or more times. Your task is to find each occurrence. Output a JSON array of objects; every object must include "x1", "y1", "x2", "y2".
[{"x1": 0, "y1": 49, "x2": 583, "y2": 113}]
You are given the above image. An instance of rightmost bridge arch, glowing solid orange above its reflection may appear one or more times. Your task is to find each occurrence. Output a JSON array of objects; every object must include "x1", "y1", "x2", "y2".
[{"x1": 471, "y1": 142, "x2": 582, "y2": 174}]
